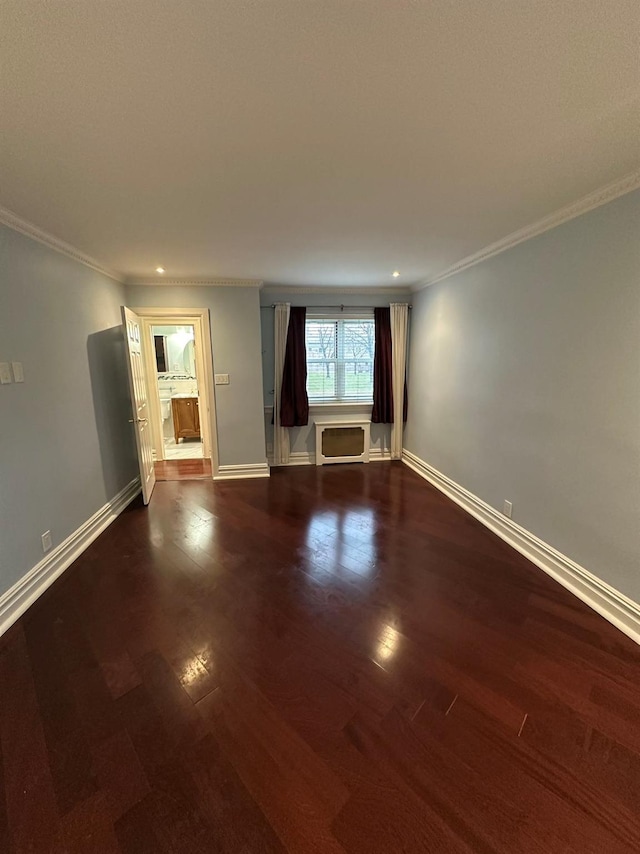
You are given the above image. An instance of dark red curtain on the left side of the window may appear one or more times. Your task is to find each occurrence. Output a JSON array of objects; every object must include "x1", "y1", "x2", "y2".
[{"x1": 280, "y1": 306, "x2": 309, "y2": 427}]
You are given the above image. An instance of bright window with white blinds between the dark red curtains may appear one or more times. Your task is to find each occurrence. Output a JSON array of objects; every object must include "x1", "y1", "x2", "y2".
[{"x1": 306, "y1": 317, "x2": 375, "y2": 403}]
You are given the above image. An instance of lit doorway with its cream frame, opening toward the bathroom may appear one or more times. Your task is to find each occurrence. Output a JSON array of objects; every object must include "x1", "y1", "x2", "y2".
[{"x1": 125, "y1": 308, "x2": 217, "y2": 488}]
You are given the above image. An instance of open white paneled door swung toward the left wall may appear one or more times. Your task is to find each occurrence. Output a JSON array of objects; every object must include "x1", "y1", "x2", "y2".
[{"x1": 122, "y1": 305, "x2": 156, "y2": 504}]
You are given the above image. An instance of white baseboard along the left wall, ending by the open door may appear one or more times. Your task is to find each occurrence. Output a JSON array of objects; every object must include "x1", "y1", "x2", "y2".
[{"x1": 0, "y1": 477, "x2": 140, "y2": 635}]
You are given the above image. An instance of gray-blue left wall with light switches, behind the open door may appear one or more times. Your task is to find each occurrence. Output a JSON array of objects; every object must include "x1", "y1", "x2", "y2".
[{"x1": 0, "y1": 226, "x2": 137, "y2": 595}]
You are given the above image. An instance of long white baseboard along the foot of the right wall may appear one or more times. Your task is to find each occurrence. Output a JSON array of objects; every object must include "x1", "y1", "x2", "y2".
[{"x1": 402, "y1": 450, "x2": 640, "y2": 643}]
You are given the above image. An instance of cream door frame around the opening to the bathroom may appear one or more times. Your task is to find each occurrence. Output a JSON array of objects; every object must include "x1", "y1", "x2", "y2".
[{"x1": 131, "y1": 306, "x2": 219, "y2": 477}]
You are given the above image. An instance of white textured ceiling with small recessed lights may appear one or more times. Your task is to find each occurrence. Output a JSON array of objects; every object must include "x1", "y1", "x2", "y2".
[{"x1": 0, "y1": 0, "x2": 640, "y2": 287}]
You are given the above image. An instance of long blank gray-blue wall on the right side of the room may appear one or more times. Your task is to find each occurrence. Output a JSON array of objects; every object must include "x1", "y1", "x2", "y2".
[{"x1": 404, "y1": 192, "x2": 640, "y2": 602}]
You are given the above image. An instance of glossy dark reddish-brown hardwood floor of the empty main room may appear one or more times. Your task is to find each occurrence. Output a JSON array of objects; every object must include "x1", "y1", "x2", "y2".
[{"x1": 0, "y1": 463, "x2": 640, "y2": 854}]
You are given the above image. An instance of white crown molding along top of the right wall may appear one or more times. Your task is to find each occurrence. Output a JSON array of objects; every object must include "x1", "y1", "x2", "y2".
[{"x1": 412, "y1": 170, "x2": 640, "y2": 292}]
